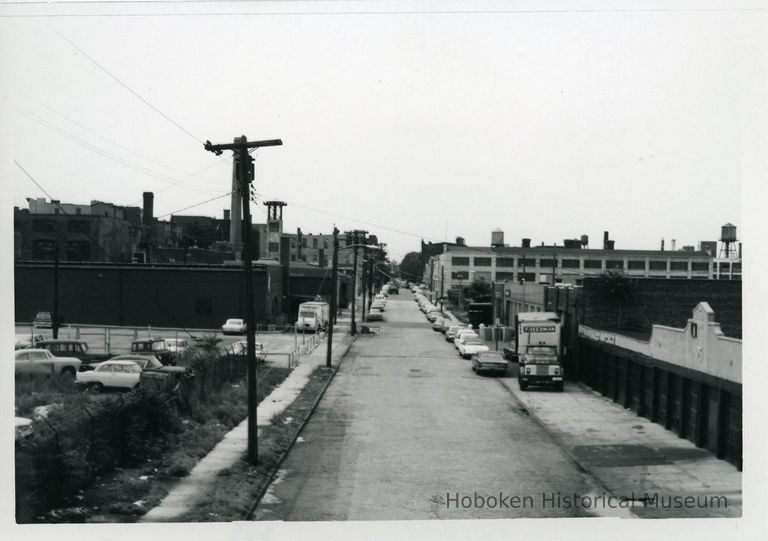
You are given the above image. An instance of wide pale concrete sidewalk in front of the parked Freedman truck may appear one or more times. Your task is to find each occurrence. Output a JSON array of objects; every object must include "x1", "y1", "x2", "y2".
[{"x1": 500, "y1": 372, "x2": 742, "y2": 518}]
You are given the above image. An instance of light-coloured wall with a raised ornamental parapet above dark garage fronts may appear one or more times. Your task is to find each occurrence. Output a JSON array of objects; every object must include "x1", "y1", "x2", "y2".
[{"x1": 579, "y1": 302, "x2": 742, "y2": 384}]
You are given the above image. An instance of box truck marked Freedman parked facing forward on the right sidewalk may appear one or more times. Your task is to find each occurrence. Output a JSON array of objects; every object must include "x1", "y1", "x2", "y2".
[{"x1": 511, "y1": 312, "x2": 565, "y2": 392}]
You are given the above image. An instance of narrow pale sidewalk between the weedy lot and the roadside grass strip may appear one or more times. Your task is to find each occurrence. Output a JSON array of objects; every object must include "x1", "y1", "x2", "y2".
[{"x1": 139, "y1": 322, "x2": 352, "y2": 522}]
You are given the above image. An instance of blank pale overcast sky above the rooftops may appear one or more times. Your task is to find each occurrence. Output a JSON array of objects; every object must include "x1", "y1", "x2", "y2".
[{"x1": 0, "y1": 1, "x2": 765, "y2": 259}]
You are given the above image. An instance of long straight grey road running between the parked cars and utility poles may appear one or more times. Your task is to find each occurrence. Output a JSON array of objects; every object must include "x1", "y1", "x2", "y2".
[{"x1": 254, "y1": 293, "x2": 594, "y2": 521}]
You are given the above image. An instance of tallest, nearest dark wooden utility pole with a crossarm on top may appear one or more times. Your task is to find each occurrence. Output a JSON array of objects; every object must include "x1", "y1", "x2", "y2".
[{"x1": 204, "y1": 135, "x2": 283, "y2": 465}]
